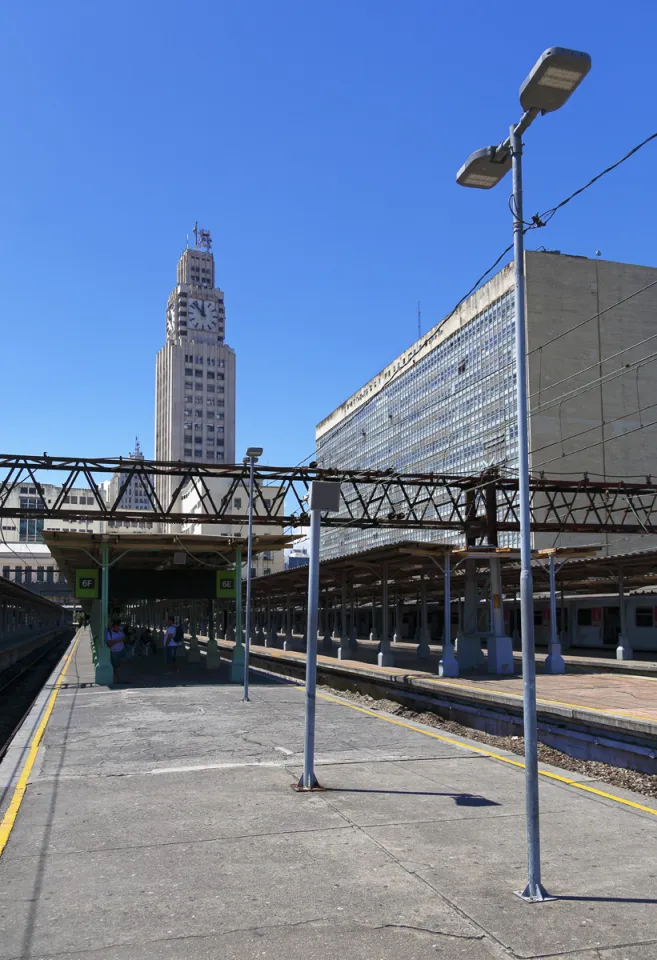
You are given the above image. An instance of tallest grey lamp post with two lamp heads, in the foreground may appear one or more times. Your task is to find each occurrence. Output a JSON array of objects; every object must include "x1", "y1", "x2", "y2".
[{"x1": 456, "y1": 47, "x2": 591, "y2": 903}]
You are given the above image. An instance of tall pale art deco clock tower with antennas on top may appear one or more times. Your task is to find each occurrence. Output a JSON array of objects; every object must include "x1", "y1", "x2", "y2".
[{"x1": 155, "y1": 229, "x2": 235, "y2": 502}]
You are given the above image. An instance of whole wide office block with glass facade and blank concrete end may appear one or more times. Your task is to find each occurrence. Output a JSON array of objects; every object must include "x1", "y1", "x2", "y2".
[{"x1": 316, "y1": 251, "x2": 657, "y2": 557}]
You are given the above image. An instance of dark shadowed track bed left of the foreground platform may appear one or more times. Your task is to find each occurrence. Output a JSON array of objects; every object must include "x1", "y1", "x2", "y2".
[{"x1": 0, "y1": 630, "x2": 71, "y2": 762}]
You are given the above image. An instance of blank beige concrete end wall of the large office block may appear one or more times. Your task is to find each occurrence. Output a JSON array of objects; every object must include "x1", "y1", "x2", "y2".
[{"x1": 526, "y1": 252, "x2": 657, "y2": 552}]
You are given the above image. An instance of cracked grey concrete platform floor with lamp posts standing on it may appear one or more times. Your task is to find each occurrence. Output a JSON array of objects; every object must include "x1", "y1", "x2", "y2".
[{"x1": 0, "y1": 635, "x2": 657, "y2": 960}]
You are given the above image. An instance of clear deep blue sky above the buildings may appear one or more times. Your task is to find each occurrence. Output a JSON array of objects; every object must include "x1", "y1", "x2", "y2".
[{"x1": 0, "y1": 0, "x2": 657, "y2": 464}]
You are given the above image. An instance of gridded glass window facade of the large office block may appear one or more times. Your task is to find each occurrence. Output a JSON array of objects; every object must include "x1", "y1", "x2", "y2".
[{"x1": 317, "y1": 291, "x2": 518, "y2": 558}]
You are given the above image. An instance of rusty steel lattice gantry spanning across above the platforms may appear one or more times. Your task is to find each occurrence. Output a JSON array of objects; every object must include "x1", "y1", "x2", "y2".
[{"x1": 0, "y1": 454, "x2": 657, "y2": 543}]
